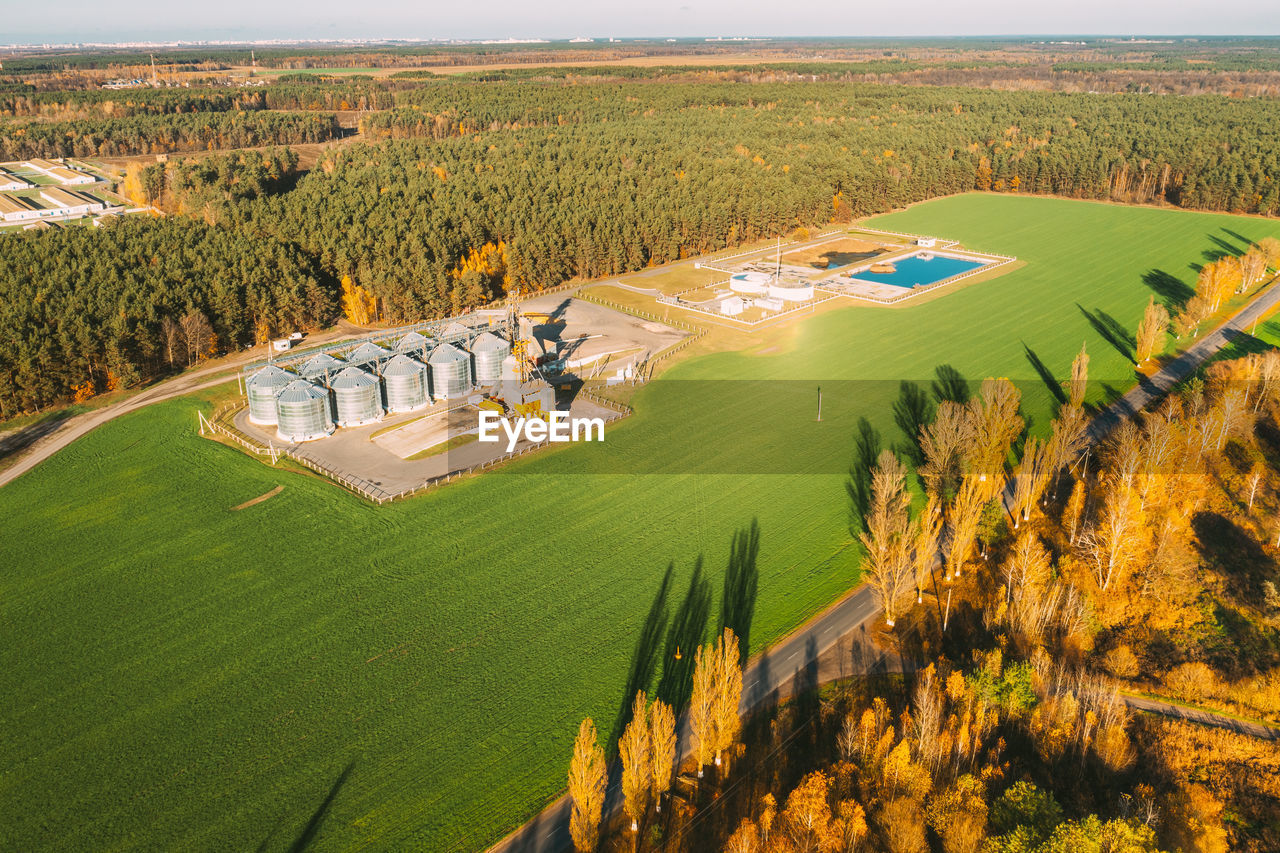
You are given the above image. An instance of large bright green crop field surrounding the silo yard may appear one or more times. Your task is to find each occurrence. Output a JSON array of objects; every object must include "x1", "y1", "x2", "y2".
[{"x1": 0, "y1": 195, "x2": 1280, "y2": 850}]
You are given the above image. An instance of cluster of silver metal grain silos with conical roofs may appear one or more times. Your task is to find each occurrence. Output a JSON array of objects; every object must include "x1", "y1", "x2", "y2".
[{"x1": 246, "y1": 325, "x2": 511, "y2": 442}]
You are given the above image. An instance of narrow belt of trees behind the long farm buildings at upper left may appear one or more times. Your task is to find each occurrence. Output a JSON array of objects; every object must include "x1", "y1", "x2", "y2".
[{"x1": 0, "y1": 110, "x2": 340, "y2": 160}]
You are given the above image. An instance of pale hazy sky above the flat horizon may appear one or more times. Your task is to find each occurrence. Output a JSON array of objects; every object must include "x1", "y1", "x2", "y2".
[{"x1": 0, "y1": 0, "x2": 1280, "y2": 44}]
